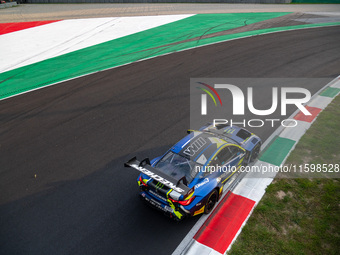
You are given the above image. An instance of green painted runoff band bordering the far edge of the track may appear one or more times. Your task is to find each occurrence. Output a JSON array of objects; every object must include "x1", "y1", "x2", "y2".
[{"x1": 0, "y1": 12, "x2": 340, "y2": 99}]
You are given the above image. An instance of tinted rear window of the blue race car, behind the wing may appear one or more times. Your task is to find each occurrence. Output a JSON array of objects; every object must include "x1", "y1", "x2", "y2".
[{"x1": 156, "y1": 152, "x2": 200, "y2": 183}]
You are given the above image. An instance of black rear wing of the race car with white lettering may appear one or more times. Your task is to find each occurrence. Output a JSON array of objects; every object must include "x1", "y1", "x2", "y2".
[{"x1": 124, "y1": 157, "x2": 191, "y2": 196}]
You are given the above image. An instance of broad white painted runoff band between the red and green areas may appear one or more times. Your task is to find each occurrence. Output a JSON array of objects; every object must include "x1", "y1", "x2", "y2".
[{"x1": 0, "y1": 14, "x2": 193, "y2": 72}]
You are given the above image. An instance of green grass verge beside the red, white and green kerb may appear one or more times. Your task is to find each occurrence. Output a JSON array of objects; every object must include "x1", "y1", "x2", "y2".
[{"x1": 228, "y1": 94, "x2": 340, "y2": 255}]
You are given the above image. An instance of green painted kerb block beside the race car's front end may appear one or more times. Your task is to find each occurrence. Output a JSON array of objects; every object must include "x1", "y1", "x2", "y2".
[{"x1": 259, "y1": 137, "x2": 295, "y2": 166}]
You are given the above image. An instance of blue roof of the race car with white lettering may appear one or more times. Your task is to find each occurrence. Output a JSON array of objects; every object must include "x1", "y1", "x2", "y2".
[{"x1": 170, "y1": 131, "x2": 235, "y2": 164}]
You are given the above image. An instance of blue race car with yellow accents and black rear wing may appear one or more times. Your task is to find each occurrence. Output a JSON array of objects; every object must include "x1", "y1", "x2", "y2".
[{"x1": 124, "y1": 124, "x2": 261, "y2": 221}]
